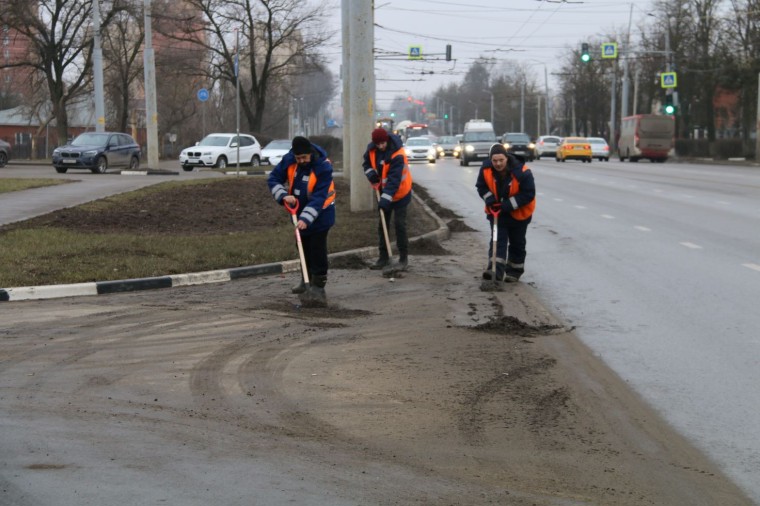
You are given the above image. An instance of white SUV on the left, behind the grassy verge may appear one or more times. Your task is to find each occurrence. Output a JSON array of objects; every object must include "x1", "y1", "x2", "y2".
[{"x1": 179, "y1": 133, "x2": 261, "y2": 172}]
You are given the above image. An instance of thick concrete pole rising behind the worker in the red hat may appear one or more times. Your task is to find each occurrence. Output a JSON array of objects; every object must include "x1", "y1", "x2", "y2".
[{"x1": 343, "y1": 0, "x2": 375, "y2": 211}]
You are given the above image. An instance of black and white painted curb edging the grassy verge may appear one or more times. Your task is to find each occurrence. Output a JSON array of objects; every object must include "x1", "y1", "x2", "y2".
[{"x1": 0, "y1": 195, "x2": 450, "y2": 302}]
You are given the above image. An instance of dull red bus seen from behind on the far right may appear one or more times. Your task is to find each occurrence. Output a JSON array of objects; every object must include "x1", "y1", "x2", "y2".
[{"x1": 618, "y1": 114, "x2": 675, "y2": 162}]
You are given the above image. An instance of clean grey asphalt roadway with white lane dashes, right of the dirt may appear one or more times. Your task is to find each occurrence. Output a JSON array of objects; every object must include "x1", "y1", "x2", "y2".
[{"x1": 413, "y1": 155, "x2": 760, "y2": 503}]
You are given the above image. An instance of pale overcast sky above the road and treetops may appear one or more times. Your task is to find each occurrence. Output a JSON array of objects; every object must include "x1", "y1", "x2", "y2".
[{"x1": 326, "y1": 0, "x2": 652, "y2": 107}]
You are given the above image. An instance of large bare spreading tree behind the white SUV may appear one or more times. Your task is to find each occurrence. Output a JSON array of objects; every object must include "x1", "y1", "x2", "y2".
[{"x1": 157, "y1": 0, "x2": 332, "y2": 132}]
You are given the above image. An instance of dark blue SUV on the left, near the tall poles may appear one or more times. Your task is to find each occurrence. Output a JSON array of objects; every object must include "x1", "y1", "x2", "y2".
[{"x1": 53, "y1": 132, "x2": 142, "y2": 174}]
